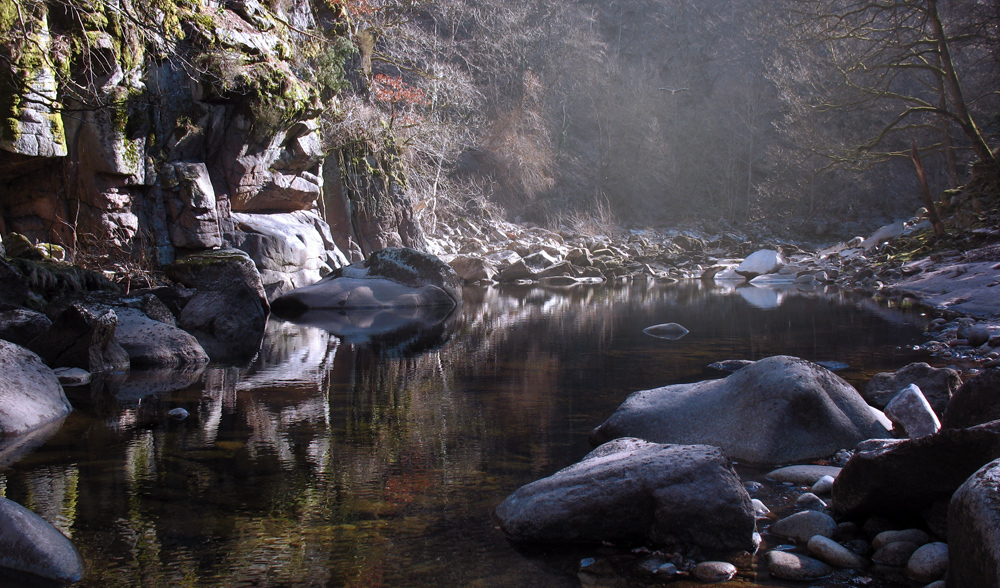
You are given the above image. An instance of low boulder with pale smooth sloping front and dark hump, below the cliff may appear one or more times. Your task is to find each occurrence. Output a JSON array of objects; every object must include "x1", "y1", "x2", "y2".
[{"x1": 274, "y1": 248, "x2": 462, "y2": 317}]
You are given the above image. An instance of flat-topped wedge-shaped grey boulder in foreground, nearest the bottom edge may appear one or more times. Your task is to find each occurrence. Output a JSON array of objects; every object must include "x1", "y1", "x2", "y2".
[{"x1": 496, "y1": 439, "x2": 755, "y2": 551}]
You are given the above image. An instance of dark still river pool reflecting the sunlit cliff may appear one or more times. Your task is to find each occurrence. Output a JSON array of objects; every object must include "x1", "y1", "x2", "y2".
[{"x1": 0, "y1": 283, "x2": 928, "y2": 588}]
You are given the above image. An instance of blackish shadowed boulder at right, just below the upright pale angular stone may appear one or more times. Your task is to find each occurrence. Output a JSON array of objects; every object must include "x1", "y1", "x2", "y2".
[{"x1": 833, "y1": 421, "x2": 1000, "y2": 518}]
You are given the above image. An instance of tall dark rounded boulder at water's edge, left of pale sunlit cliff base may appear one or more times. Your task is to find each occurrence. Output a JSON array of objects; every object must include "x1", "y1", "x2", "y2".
[{"x1": 166, "y1": 249, "x2": 270, "y2": 361}]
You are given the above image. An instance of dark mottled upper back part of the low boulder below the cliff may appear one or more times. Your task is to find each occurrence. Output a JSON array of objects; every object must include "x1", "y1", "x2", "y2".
[{"x1": 365, "y1": 247, "x2": 462, "y2": 304}]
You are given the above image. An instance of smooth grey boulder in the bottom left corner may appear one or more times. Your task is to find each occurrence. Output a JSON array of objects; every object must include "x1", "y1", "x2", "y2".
[{"x1": 0, "y1": 498, "x2": 83, "y2": 584}]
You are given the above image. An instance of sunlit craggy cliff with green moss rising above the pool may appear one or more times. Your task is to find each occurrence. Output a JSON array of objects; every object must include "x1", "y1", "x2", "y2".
[{"x1": 0, "y1": 0, "x2": 423, "y2": 297}]
